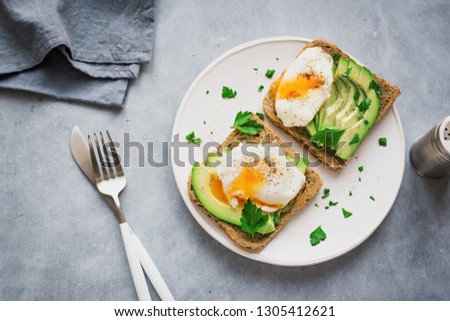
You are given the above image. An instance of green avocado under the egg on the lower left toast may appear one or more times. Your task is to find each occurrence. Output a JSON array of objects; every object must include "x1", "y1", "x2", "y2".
[{"x1": 191, "y1": 154, "x2": 309, "y2": 234}]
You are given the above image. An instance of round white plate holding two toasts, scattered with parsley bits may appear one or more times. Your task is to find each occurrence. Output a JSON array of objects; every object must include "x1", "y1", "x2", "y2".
[{"x1": 171, "y1": 37, "x2": 405, "y2": 266}]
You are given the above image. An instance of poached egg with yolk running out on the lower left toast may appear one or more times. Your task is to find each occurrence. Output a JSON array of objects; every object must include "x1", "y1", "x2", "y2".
[{"x1": 210, "y1": 143, "x2": 305, "y2": 212}]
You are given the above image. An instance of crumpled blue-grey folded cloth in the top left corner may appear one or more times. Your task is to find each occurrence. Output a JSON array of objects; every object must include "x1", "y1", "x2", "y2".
[{"x1": 0, "y1": 0, "x2": 154, "y2": 107}]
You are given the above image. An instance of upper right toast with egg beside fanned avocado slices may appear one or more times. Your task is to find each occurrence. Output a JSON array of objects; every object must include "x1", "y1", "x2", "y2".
[{"x1": 263, "y1": 40, "x2": 400, "y2": 170}]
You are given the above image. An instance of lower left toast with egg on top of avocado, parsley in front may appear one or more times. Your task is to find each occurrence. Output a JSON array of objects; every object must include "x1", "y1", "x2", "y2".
[{"x1": 188, "y1": 112, "x2": 322, "y2": 250}]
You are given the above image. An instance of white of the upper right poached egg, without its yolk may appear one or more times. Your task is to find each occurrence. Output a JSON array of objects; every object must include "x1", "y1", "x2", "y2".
[{"x1": 275, "y1": 47, "x2": 333, "y2": 127}]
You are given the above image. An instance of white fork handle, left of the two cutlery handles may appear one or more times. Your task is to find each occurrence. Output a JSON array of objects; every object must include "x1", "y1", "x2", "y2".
[{"x1": 120, "y1": 222, "x2": 152, "y2": 301}]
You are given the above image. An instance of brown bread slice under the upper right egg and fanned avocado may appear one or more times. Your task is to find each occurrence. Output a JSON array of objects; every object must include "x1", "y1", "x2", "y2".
[{"x1": 263, "y1": 40, "x2": 400, "y2": 170}]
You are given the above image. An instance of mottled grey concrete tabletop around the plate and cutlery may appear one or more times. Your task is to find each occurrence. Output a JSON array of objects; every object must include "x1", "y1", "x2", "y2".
[{"x1": 0, "y1": 0, "x2": 450, "y2": 300}]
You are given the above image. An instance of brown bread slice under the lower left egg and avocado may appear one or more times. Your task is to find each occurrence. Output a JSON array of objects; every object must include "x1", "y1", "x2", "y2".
[{"x1": 188, "y1": 116, "x2": 322, "y2": 250}]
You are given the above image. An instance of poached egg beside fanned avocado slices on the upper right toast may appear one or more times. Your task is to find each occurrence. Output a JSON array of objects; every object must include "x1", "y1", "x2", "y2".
[{"x1": 275, "y1": 47, "x2": 333, "y2": 127}]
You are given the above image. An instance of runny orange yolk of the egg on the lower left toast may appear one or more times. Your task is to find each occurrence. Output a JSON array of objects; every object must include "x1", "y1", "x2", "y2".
[{"x1": 210, "y1": 167, "x2": 265, "y2": 204}]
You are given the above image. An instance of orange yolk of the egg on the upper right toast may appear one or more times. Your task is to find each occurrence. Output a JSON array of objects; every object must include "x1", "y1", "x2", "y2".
[{"x1": 276, "y1": 74, "x2": 325, "y2": 99}]
